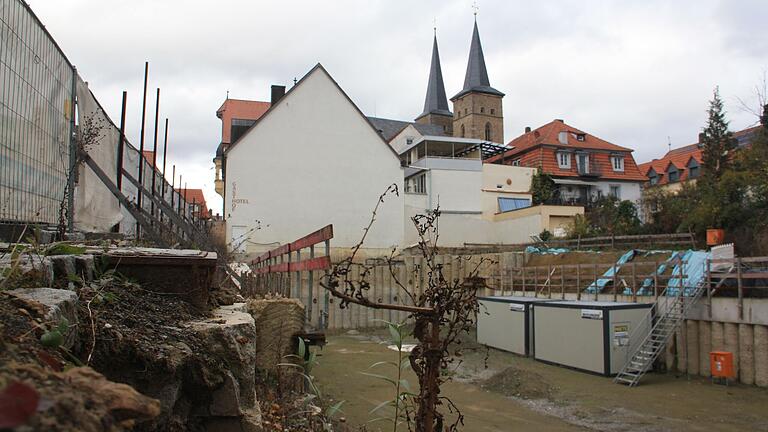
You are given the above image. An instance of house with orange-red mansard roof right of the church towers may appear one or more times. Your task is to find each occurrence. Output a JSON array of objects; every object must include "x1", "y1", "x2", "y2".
[{"x1": 486, "y1": 119, "x2": 646, "y2": 205}]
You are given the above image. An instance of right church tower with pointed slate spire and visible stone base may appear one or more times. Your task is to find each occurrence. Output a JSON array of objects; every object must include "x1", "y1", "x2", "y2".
[{"x1": 451, "y1": 19, "x2": 504, "y2": 143}]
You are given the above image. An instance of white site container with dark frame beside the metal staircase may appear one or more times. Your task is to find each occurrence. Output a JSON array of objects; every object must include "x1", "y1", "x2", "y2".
[{"x1": 532, "y1": 301, "x2": 653, "y2": 376}]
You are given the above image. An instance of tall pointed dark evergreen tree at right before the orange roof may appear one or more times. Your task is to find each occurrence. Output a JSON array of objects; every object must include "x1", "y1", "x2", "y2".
[{"x1": 701, "y1": 87, "x2": 736, "y2": 181}]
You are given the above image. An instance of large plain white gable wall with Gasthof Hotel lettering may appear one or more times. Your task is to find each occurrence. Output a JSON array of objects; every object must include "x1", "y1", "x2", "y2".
[{"x1": 225, "y1": 68, "x2": 403, "y2": 252}]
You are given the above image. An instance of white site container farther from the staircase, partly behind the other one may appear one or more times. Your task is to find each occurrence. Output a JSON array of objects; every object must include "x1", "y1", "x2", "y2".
[{"x1": 477, "y1": 296, "x2": 552, "y2": 356}]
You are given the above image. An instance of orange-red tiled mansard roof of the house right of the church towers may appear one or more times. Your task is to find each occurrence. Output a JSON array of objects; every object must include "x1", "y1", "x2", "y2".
[{"x1": 486, "y1": 120, "x2": 647, "y2": 181}]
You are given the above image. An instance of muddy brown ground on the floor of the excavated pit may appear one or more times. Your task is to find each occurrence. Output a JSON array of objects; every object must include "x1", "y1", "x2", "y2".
[{"x1": 314, "y1": 332, "x2": 768, "y2": 432}]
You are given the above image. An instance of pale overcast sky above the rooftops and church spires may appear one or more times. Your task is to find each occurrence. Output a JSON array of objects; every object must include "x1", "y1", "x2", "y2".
[{"x1": 29, "y1": 0, "x2": 768, "y2": 211}]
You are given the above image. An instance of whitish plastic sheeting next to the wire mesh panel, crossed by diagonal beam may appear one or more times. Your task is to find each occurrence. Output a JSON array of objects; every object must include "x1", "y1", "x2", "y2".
[{"x1": 74, "y1": 76, "x2": 123, "y2": 232}]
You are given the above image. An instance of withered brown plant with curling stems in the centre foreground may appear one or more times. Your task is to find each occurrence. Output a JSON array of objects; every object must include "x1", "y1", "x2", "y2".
[{"x1": 320, "y1": 184, "x2": 488, "y2": 432}]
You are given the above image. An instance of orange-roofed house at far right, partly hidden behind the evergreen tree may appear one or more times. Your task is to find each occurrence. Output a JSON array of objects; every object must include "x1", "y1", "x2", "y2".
[{"x1": 639, "y1": 126, "x2": 760, "y2": 192}]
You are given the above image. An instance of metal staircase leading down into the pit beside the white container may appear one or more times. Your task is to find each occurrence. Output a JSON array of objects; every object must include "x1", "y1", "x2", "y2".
[{"x1": 613, "y1": 278, "x2": 707, "y2": 387}]
